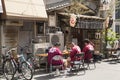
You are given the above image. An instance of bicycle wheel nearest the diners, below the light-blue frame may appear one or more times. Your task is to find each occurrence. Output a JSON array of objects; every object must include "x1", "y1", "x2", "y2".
[{"x1": 21, "y1": 62, "x2": 33, "y2": 80}]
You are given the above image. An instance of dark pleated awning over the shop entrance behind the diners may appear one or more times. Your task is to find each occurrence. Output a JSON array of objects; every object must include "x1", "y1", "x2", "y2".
[{"x1": 59, "y1": 13, "x2": 105, "y2": 29}]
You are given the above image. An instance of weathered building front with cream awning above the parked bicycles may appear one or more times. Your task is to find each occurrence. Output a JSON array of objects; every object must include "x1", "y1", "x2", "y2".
[{"x1": 0, "y1": 0, "x2": 47, "y2": 53}]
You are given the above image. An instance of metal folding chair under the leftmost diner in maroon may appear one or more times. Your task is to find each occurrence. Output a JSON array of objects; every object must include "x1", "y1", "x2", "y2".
[{"x1": 50, "y1": 55, "x2": 64, "y2": 73}]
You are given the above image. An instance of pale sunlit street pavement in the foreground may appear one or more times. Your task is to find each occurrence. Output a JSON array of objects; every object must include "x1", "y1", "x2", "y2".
[{"x1": 0, "y1": 62, "x2": 120, "y2": 80}]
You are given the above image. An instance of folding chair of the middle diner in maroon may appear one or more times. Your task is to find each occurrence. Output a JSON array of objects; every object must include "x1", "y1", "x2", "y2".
[{"x1": 71, "y1": 52, "x2": 85, "y2": 74}]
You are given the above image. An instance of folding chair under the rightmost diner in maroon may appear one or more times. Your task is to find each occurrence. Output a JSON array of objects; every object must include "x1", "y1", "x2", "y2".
[{"x1": 85, "y1": 50, "x2": 96, "y2": 69}]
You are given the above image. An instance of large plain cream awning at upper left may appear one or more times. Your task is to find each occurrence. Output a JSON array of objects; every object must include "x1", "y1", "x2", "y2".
[{"x1": 4, "y1": 0, "x2": 47, "y2": 20}]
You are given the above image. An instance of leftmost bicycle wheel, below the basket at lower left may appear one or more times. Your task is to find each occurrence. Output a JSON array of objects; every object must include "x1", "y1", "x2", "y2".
[{"x1": 3, "y1": 59, "x2": 15, "y2": 80}]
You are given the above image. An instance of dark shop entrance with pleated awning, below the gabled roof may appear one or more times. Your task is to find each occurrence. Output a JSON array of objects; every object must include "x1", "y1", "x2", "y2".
[{"x1": 60, "y1": 13, "x2": 104, "y2": 52}]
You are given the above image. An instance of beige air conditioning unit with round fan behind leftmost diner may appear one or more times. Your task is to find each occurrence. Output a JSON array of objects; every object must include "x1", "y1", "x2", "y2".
[{"x1": 47, "y1": 31, "x2": 64, "y2": 50}]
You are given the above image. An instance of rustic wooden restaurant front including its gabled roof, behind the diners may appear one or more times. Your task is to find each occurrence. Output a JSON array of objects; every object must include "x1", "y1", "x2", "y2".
[{"x1": 45, "y1": 0, "x2": 104, "y2": 51}]
